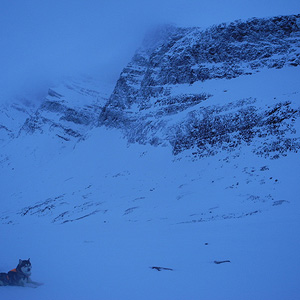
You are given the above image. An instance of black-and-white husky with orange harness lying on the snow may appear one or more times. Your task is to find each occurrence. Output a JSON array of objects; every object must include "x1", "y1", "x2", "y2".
[{"x1": 0, "y1": 258, "x2": 42, "y2": 287}]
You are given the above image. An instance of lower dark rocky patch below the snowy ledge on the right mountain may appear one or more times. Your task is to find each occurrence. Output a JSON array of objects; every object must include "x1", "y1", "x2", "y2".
[{"x1": 170, "y1": 99, "x2": 300, "y2": 157}]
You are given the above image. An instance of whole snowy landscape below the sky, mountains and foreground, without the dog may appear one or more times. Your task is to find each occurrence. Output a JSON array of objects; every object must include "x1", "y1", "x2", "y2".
[{"x1": 0, "y1": 15, "x2": 300, "y2": 300}]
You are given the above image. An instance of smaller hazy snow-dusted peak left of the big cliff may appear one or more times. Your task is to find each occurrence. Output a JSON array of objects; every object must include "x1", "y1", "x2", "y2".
[{"x1": 19, "y1": 79, "x2": 113, "y2": 142}]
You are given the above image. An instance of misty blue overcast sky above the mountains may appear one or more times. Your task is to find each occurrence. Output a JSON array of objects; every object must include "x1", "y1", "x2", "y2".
[{"x1": 0, "y1": 0, "x2": 300, "y2": 102}]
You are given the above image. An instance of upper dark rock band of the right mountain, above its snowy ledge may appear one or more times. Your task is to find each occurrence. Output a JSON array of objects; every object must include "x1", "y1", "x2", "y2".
[{"x1": 101, "y1": 15, "x2": 300, "y2": 115}]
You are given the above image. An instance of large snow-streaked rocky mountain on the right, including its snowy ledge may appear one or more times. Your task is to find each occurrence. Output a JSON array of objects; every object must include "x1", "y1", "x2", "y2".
[{"x1": 100, "y1": 15, "x2": 300, "y2": 157}]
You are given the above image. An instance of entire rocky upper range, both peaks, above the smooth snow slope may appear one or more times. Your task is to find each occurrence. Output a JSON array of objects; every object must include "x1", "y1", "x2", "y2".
[{"x1": 0, "y1": 15, "x2": 300, "y2": 157}]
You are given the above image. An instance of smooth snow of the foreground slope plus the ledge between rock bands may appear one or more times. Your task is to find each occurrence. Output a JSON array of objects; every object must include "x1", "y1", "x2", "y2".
[{"x1": 0, "y1": 67, "x2": 300, "y2": 300}]
